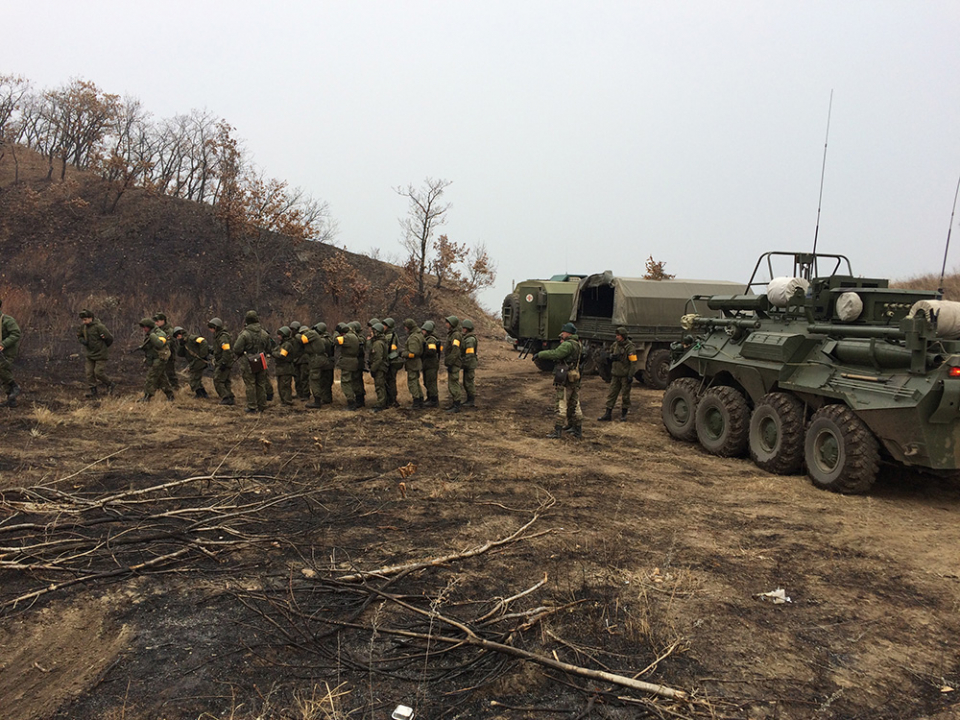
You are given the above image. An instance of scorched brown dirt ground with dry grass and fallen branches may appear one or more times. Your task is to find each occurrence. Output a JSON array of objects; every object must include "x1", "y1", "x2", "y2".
[{"x1": 0, "y1": 339, "x2": 960, "y2": 720}]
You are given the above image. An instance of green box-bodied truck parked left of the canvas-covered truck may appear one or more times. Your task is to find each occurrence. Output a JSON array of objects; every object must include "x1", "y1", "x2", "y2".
[{"x1": 501, "y1": 275, "x2": 583, "y2": 371}]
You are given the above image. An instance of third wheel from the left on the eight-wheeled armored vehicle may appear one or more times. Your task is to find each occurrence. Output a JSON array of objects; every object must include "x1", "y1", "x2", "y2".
[{"x1": 750, "y1": 392, "x2": 804, "y2": 475}]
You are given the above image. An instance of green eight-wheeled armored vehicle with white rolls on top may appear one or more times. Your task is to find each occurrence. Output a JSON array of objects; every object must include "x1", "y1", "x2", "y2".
[{"x1": 661, "y1": 252, "x2": 960, "y2": 493}]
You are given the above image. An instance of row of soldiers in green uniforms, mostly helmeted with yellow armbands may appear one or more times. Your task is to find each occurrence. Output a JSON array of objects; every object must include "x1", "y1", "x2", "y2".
[{"x1": 75, "y1": 310, "x2": 478, "y2": 413}]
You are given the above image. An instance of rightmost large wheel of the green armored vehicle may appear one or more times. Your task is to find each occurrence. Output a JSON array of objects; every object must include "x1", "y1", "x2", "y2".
[{"x1": 803, "y1": 405, "x2": 880, "y2": 495}]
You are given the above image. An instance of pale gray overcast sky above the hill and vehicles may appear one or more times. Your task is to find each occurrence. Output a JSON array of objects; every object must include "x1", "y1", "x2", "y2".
[{"x1": 7, "y1": 0, "x2": 960, "y2": 309}]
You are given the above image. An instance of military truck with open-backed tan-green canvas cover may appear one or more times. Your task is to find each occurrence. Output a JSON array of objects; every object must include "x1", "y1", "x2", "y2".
[{"x1": 569, "y1": 270, "x2": 743, "y2": 390}]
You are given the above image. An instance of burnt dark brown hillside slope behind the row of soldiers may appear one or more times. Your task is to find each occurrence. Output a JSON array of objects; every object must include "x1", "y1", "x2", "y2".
[{"x1": 0, "y1": 148, "x2": 497, "y2": 363}]
